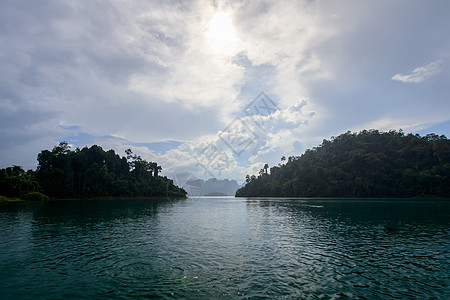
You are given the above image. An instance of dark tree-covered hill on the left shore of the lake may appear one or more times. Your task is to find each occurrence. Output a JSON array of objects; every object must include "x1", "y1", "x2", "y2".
[{"x1": 0, "y1": 142, "x2": 186, "y2": 198}]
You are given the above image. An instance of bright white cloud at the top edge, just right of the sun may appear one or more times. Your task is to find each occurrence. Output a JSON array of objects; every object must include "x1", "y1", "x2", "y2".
[{"x1": 236, "y1": 1, "x2": 336, "y2": 105}]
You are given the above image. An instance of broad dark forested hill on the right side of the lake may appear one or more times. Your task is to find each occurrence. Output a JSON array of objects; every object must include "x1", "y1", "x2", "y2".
[{"x1": 236, "y1": 130, "x2": 450, "y2": 198}]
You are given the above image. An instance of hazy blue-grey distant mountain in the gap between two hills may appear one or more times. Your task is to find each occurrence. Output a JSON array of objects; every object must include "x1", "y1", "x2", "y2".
[{"x1": 183, "y1": 178, "x2": 241, "y2": 197}]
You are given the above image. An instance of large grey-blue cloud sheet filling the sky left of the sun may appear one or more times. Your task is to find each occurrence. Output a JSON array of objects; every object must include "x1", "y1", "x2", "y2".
[{"x1": 0, "y1": 1, "x2": 242, "y2": 152}]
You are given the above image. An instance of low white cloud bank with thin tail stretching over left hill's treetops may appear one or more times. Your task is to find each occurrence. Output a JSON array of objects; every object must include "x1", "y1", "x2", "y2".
[{"x1": 83, "y1": 100, "x2": 314, "y2": 182}]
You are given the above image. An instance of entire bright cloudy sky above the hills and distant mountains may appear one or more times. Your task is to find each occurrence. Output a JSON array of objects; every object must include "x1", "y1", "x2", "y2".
[{"x1": 0, "y1": 0, "x2": 450, "y2": 182}]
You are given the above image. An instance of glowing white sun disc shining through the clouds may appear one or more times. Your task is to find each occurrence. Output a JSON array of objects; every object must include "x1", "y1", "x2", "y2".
[{"x1": 206, "y1": 11, "x2": 237, "y2": 55}]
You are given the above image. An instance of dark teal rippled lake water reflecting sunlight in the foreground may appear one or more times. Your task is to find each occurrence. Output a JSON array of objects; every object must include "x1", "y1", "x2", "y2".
[{"x1": 0, "y1": 197, "x2": 450, "y2": 299}]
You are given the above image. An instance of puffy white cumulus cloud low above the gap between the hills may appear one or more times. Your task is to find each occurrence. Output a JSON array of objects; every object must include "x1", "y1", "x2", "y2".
[{"x1": 156, "y1": 100, "x2": 314, "y2": 180}]
